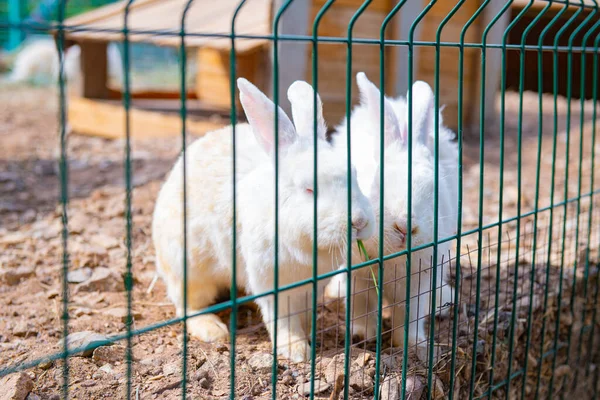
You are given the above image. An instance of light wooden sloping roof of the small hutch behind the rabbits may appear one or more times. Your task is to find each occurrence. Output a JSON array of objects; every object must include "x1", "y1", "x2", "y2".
[{"x1": 65, "y1": 0, "x2": 271, "y2": 53}]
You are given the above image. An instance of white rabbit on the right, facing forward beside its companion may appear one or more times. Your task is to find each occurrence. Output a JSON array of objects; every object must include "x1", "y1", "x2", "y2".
[{"x1": 326, "y1": 73, "x2": 457, "y2": 355}]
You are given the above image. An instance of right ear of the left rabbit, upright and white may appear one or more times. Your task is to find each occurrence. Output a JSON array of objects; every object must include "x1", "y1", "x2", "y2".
[{"x1": 288, "y1": 81, "x2": 327, "y2": 140}]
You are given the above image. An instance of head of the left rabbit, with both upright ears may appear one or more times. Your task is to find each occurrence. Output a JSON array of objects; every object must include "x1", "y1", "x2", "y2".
[{"x1": 238, "y1": 78, "x2": 375, "y2": 264}]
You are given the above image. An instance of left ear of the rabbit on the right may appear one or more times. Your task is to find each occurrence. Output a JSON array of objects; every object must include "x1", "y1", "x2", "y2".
[{"x1": 356, "y1": 72, "x2": 405, "y2": 146}]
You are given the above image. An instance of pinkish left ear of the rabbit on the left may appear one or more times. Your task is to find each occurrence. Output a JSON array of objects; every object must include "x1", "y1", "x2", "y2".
[{"x1": 237, "y1": 78, "x2": 298, "y2": 154}]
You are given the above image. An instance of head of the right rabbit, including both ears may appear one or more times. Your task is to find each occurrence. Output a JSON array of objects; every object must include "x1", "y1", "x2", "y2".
[{"x1": 352, "y1": 73, "x2": 444, "y2": 251}]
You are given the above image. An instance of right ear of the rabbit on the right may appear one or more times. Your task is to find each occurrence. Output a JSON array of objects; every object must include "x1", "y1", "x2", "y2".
[{"x1": 406, "y1": 81, "x2": 434, "y2": 144}]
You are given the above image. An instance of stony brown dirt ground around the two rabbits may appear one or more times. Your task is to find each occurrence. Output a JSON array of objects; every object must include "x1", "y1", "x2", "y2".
[{"x1": 0, "y1": 83, "x2": 600, "y2": 400}]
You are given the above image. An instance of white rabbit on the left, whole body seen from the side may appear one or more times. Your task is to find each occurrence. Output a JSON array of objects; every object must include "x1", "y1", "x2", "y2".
[{"x1": 152, "y1": 78, "x2": 375, "y2": 361}]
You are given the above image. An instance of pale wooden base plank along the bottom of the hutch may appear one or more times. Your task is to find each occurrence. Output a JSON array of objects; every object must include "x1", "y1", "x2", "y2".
[{"x1": 67, "y1": 96, "x2": 227, "y2": 139}]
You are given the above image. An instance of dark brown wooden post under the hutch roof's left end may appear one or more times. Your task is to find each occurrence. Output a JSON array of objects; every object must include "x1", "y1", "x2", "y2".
[{"x1": 80, "y1": 42, "x2": 109, "y2": 99}]
